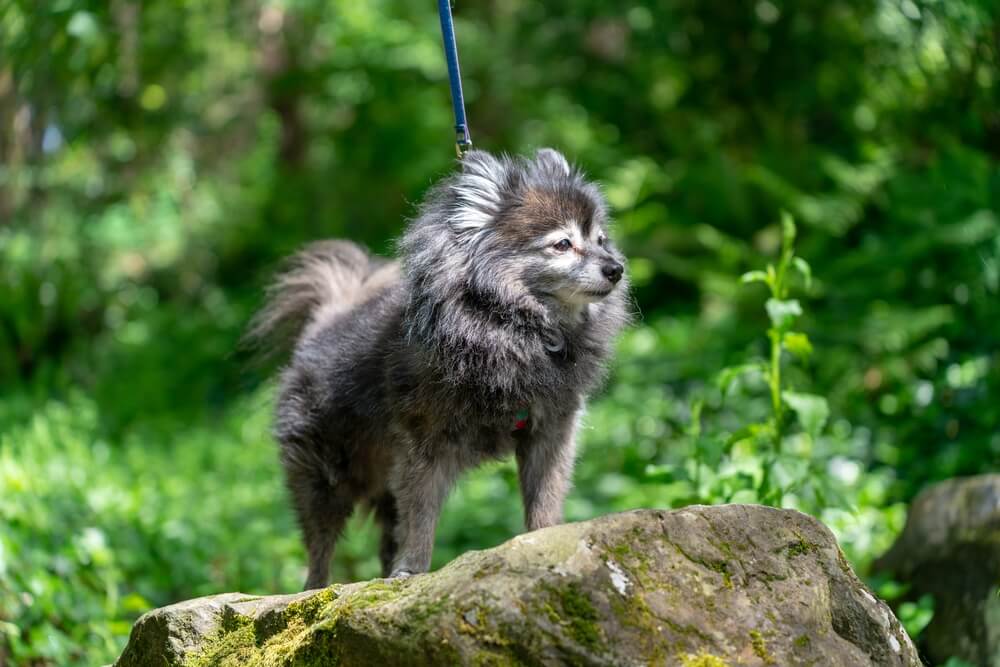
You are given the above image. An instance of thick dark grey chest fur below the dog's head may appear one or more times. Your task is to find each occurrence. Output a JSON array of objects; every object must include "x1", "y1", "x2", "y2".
[{"x1": 386, "y1": 292, "x2": 608, "y2": 458}]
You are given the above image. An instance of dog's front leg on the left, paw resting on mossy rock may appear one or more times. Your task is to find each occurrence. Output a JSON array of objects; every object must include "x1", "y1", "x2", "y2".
[{"x1": 389, "y1": 450, "x2": 457, "y2": 577}]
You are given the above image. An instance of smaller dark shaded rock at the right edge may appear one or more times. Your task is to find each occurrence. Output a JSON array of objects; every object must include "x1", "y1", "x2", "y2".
[{"x1": 875, "y1": 475, "x2": 1000, "y2": 667}]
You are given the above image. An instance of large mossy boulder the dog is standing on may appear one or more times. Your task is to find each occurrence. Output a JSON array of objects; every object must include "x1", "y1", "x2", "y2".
[{"x1": 117, "y1": 505, "x2": 920, "y2": 667}]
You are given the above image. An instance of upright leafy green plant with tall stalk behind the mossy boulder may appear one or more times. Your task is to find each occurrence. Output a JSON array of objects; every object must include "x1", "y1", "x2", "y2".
[{"x1": 628, "y1": 214, "x2": 895, "y2": 528}]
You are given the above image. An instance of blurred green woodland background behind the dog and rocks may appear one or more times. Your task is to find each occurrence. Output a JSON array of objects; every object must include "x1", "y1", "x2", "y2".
[{"x1": 0, "y1": 0, "x2": 1000, "y2": 665}]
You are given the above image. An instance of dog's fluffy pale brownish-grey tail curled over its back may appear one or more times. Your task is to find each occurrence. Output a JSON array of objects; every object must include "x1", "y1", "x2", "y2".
[{"x1": 243, "y1": 241, "x2": 399, "y2": 358}]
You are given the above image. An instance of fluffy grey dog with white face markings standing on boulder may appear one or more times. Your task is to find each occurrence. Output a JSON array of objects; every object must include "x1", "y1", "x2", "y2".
[{"x1": 250, "y1": 149, "x2": 628, "y2": 588}]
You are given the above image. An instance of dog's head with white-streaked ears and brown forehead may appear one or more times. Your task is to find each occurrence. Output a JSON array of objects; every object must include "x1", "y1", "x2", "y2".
[{"x1": 423, "y1": 148, "x2": 625, "y2": 308}]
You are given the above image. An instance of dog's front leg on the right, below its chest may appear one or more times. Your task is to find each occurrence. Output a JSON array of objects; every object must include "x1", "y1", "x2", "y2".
[{"x1": 517, "y1": 414, "x2": 578, "y2": 531}]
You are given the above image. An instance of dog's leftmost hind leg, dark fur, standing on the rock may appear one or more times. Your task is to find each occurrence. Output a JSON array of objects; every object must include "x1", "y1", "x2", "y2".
[{"x1": 287, "y1": 469, "x2": 355, "y2": 590}]
